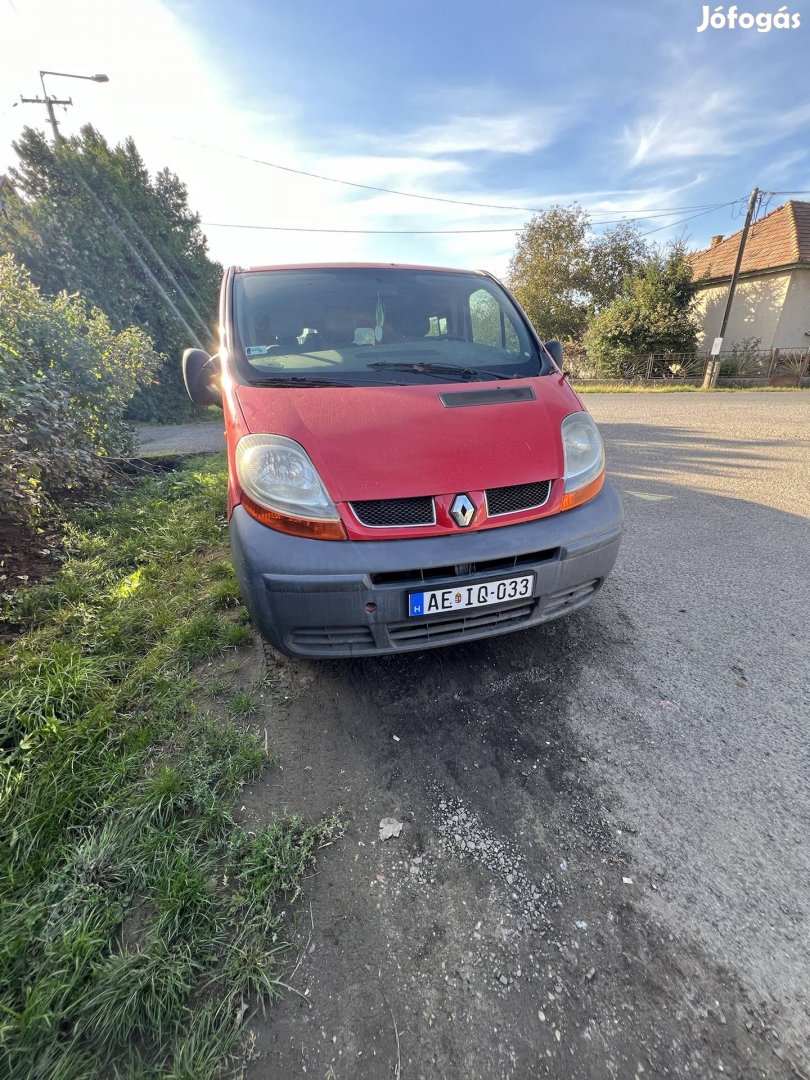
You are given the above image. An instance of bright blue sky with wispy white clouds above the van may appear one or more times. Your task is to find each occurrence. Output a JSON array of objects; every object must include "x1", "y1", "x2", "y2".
[{"x1": 0, "y1": 0, "x2": 810, "y2": 275}]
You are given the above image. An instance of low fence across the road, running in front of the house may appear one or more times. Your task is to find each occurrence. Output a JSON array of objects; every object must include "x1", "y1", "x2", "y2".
[{"x1": 565, "y1": 349, "x2": 810, "y2": 386}]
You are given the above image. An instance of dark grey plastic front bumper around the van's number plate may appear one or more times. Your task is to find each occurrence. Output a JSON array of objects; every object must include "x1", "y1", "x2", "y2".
[{"x1": 230, "y1": 482, "x2": 623, "y2": 657}]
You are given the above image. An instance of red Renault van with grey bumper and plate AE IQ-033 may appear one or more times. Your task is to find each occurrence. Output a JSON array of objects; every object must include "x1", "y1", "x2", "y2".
[{"x1": 183, "y1": 264, "x2": 622, "y2": 657}]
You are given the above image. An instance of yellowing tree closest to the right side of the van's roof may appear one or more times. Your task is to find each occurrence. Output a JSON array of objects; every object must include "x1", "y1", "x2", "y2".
[{"x1": 508, "y1": 204, "x2": 647, "y2": 341}]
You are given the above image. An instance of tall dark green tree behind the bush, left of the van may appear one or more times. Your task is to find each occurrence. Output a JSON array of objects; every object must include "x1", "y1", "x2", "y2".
[{"x1": 0, "y1": 126, "x2": 221, "y2": 419}]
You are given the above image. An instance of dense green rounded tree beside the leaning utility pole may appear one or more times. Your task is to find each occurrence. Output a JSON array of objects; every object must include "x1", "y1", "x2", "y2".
[{"x1": 584, "y1": 243, "x2": 700, "y2": 375}]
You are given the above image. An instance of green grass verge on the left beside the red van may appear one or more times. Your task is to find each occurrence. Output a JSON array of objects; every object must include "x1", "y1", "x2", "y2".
[{"x1": 0, "y1": 458, "x2": 338, "y2": 1080}]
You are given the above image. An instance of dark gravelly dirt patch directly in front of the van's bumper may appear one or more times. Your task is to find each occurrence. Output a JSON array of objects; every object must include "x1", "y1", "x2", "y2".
[{"x1": 216, "y1": 626, "x2": 796, "y2": 1080}]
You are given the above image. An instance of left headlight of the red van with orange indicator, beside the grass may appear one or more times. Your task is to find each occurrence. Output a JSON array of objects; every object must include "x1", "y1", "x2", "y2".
[{"x1": 235, "y1": 435, "x2": 346, "y2": 540}]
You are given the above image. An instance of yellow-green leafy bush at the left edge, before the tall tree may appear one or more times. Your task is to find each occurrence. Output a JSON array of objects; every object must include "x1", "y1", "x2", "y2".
[{"x1": 0, "y1": 255, "x2": 163, "y2": 521}]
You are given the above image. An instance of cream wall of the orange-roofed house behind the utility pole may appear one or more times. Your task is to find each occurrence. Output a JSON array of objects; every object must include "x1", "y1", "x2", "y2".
[{"x1": 697, "y1": 270, "x2": 794, "y2": 351}]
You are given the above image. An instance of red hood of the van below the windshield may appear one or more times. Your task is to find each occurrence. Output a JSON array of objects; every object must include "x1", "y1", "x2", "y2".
[{"x1": 235, "y1": 374, "x2": 582, "y2": 502}]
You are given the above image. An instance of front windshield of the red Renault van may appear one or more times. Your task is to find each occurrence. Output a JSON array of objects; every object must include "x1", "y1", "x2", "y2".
[{"x1": 233, "y1": 267, "x2": 544, "y2": 386}]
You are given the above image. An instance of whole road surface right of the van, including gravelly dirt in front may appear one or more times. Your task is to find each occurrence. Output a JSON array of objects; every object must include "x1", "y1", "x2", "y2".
[{"x1": 192, "y1": 393, "x2": 810, "y2": 1080}]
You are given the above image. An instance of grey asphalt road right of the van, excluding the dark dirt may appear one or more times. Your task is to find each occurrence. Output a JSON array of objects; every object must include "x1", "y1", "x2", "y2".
[{"x1": 572, "y1": 394, "x2": 810, "y2": 1041}]
